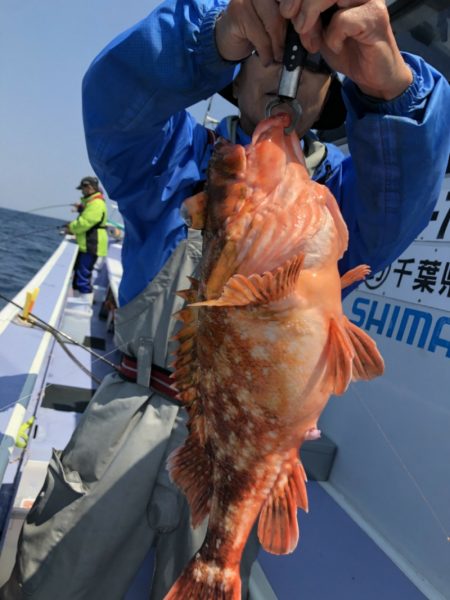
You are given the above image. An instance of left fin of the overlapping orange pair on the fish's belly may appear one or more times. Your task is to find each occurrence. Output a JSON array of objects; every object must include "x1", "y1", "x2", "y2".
[{"x1": 323, "y1": 318, "x2": 355, "y2": 395}]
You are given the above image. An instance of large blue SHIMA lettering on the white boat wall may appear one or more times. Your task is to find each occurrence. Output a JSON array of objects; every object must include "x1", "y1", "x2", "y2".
[{"x1": 350, "y1": 297, "x2": 450, "y2": 358}]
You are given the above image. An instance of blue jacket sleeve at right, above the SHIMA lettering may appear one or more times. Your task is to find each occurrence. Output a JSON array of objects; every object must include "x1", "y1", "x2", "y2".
[{"x1": 339, "y1": 54, "x2": 450, "y2": 273}]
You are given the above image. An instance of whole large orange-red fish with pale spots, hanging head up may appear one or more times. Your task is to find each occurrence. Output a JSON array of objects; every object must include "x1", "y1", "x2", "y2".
[{"x1": 166, "y1": 115, "x2": 383, "y2": 600}]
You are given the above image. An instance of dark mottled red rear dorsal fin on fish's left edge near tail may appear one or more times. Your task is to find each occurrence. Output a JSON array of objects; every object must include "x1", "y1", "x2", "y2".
[{"x1": 167, "y1": 422, "x2": 213, "y2": 528}]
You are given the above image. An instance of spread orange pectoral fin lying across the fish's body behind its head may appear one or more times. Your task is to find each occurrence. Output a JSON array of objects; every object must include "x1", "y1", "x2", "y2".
[{"x1": 192, "y1": 254, "x2": 304, "y2": 306}]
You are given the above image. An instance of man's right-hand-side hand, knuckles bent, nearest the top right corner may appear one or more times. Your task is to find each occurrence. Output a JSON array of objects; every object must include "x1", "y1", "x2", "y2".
[{"x1": 280, "y1": 0, "x2": 413, "y2": 100}]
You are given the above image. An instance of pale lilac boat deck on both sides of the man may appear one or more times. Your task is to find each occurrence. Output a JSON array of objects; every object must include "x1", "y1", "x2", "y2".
[{"x1": 0, "y1": 241, "x2": 425, "y2": 600}]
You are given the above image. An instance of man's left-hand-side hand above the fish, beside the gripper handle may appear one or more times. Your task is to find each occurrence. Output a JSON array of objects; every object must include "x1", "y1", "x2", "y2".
[{"x1": 215, "y1": 0, "x2": 286, "y2": 67}]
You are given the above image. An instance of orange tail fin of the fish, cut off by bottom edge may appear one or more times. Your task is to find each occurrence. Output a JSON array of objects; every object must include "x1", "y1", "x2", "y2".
[{"x1": 164, "y1": 553, "x2": 241, "y2": 600}]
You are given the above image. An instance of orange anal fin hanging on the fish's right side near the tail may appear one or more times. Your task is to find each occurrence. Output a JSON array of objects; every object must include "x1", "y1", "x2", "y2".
[{"x1": 258, "y1": 456, "x2": 308, "y2": 554}]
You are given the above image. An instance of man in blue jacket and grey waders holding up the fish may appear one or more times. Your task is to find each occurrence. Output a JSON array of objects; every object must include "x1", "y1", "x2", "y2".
[{"x1": 3, "y1": 0, "x2": 450, "y2": 600}]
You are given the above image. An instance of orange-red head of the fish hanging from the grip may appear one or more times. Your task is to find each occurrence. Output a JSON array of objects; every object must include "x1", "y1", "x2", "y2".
[{"x1": 200, "y1": 113, "x2": 332, "y2": 300}]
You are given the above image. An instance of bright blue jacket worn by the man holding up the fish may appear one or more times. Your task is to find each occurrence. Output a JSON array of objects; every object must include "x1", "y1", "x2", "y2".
[{"x1": 83, "y1": 0, "x2": 450, "y2": 305}]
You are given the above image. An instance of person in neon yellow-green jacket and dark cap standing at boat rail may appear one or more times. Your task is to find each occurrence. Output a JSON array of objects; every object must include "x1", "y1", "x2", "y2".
[{"x1": 65, "y1": 177, "x2": 108, "y2": 303}]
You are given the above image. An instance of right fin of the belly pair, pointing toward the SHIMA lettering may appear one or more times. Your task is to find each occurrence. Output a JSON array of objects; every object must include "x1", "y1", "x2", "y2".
[{"x1": 344, "y1": 317, "x2": 384, "y2": 381}]
